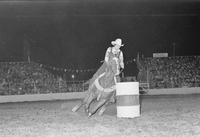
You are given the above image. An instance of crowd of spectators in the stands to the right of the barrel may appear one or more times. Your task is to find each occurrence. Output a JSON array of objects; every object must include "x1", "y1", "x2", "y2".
[{"x1": 139, "y1": 56, "x2": 200, "y2": 88}]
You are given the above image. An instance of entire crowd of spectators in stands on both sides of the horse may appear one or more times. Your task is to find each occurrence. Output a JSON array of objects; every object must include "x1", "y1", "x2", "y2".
[{"x1": 0, "y1": 56, "x2": 200, "y2": 95}]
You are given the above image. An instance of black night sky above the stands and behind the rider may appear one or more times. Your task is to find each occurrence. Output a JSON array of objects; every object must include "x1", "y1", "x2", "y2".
[{"x1": 0, "y1": 0, "x2": 200, "y2": 78}]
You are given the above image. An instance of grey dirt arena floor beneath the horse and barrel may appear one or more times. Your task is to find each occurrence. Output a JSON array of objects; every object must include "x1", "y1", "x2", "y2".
[{"x1": 0, "y1": 95, "x2": 200, "y2": 137}]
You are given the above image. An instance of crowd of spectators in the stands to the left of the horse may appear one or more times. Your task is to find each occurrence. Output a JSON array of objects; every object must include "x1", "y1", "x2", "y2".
[{"x1": 0, "y1": 62, "x2": 83, "y2": 95}]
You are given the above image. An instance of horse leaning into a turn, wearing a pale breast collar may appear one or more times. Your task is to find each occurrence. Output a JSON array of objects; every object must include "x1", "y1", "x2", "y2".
[{"x1": 72, "y1": 58, "x2": 118, "y2": 117}]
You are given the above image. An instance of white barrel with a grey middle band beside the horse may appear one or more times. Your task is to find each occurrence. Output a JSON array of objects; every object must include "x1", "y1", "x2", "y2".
[{"x1": 116, "y1": 82, "x2": 140, "y2": 118}]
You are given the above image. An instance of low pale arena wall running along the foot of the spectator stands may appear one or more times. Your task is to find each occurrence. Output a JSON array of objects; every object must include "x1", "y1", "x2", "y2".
[{"x1": 0, "y1": 87, "x2": 200, "y2": 103}]
